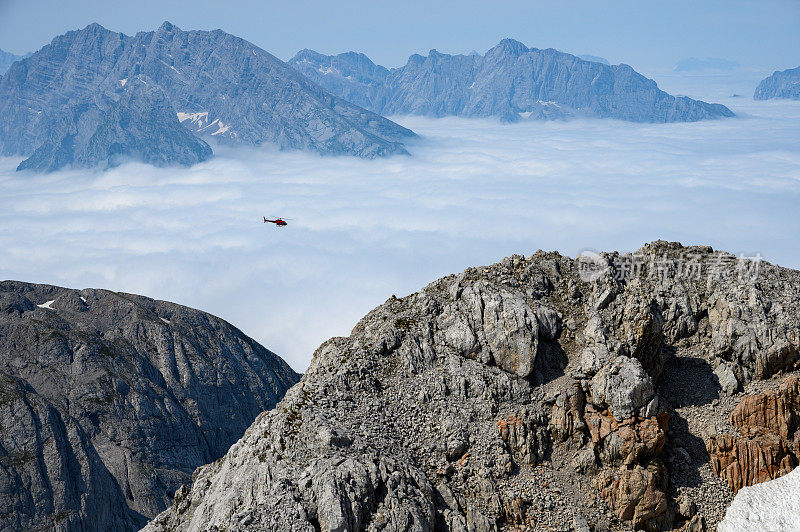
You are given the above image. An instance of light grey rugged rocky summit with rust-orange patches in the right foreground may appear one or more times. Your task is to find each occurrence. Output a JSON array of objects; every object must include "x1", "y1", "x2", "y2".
[{"x1": 146, "y1": 242, "x2": 800, "y2": 532}]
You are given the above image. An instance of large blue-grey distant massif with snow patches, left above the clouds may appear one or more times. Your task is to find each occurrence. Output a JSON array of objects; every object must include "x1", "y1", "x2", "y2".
[{"x1": 0, "y1": 22, "x2": 414, "y2": 171}]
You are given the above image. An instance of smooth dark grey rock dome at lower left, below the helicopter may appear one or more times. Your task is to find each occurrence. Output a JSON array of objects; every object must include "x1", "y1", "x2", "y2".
[{"x1": 0, "y1": 281, "x2": 299, "y2": 532}]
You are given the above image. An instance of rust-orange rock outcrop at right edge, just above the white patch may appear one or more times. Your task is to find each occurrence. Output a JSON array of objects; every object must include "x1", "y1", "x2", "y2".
[{"x1": 706, "y1": 377, "x2": 800, "y2": 493}]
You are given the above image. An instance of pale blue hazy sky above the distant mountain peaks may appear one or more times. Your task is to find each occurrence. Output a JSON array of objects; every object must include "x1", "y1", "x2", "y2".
[{"x1": 0, "y1": 0, "x2": 800, "y2": 73}]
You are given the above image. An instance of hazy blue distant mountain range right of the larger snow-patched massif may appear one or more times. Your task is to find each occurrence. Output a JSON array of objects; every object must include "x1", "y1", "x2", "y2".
[{"x1": 289, "y1": 39, "x2": 733, "y2": 122}]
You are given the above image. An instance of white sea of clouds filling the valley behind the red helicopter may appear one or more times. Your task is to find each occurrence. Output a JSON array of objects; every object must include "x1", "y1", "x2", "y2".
[{"x1": 0, "y1": 78, "x2": 800, "y2": 371}]
